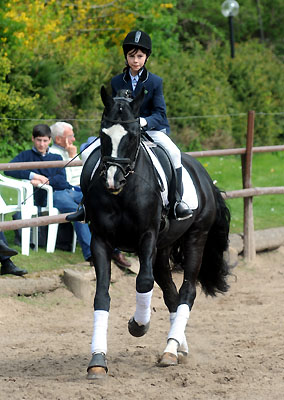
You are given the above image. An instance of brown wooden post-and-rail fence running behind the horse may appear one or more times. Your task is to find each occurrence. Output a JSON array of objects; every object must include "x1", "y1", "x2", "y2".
[{"x1": 0, "y1": 111, "x2": 284, "y2": 261}]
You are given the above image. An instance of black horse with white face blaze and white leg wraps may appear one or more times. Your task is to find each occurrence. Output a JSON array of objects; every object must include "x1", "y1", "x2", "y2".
[{"x1": 81, "y1": 87, "x2": 230, "y2": 379}]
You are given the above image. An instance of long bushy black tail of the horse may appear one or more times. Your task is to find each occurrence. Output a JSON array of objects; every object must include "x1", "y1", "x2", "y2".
[{"x1": 198, "y1": 185, "x2": 231, "y2": 296}]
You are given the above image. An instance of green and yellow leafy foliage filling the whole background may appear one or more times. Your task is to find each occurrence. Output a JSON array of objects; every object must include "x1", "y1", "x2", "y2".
[{"x1": 0, "y1": 0, "x2": 284, "y2": 155}]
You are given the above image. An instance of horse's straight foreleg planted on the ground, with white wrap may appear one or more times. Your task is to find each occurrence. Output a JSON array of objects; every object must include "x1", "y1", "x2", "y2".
[{"x1": 87, "y1": 234, "x2": 111, "y2": 379}]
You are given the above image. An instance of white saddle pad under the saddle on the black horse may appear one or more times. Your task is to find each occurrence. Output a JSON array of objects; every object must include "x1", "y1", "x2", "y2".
[{"x1": 144, "y1": 142, "x2": 198, "y2": 210}]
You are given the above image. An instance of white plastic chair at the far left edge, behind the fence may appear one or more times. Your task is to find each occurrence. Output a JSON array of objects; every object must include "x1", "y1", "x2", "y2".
[{"x1": 0, "y1": 174, "x2": 38, "y2": 256}]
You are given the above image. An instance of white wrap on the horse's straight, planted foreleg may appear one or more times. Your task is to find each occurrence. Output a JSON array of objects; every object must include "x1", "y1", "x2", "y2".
[{"x1": 91, "y1": 310, "x2": 109, "y2": 354}]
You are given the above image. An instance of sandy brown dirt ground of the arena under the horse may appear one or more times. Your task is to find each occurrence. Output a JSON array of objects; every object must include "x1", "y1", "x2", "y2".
[{"x1": 0, "y1": 247, "x2": 284, "y2": 400}]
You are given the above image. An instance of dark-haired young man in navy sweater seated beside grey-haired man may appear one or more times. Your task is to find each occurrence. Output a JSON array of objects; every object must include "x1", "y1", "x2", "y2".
[{"x1": 5, "y1": 124, "x2": 92, "y2": 262}]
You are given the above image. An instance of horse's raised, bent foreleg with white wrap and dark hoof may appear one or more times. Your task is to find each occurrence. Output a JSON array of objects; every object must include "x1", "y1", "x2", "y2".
[{"x1": 128, "y1": 232, "x2": 155, "y2": 337}]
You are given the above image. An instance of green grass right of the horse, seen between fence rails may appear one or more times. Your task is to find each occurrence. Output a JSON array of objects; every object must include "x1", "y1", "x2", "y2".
[{"x1": 199, "y1": 152, "x2": 284, "y2": 233}]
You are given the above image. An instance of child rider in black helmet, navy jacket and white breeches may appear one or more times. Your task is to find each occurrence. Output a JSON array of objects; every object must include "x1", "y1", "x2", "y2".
[{"x1": 68, "y1": 30, "x2": 192, "y2": 220}]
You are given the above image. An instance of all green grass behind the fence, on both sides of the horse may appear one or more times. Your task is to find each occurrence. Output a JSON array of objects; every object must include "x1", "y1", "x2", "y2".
[{"x1": 0, "y1": 152, "x2": 284, "y2": 272}]
